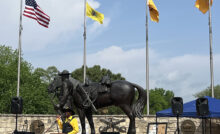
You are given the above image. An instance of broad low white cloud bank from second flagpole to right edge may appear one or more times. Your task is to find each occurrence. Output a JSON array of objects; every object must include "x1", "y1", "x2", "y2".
[{"x1": 88, "y1": 46, "x2": 220, "y2": 101}]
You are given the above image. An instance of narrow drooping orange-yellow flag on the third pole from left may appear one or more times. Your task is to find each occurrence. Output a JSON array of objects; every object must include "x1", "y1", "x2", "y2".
[{"x1": 148, "y1": 0, "x2": 159, "y2": 22}]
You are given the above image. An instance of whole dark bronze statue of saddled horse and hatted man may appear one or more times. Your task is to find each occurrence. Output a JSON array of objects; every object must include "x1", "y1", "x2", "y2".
[{"x1": 48, "y1": 72, "x2": 147, "y2": 134}]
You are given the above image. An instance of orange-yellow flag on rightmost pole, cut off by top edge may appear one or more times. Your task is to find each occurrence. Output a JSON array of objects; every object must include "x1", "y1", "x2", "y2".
[{"x1": 195, "y1": 0, "x2": 213, "y2": 14}]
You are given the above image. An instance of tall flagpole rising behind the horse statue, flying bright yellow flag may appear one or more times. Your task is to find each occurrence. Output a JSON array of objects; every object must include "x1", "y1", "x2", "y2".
[{"x1": 83, "y1": 0, "x2": 86, "y2": 83}]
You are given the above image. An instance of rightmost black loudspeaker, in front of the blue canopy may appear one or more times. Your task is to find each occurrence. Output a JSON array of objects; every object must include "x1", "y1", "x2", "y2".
[{"x1": 196, "y1": 98, "x2": 209, "y2": 116}]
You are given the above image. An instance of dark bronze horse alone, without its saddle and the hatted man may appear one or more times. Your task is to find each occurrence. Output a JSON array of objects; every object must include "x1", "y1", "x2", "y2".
[{"x1": 48, "y1": 76, "x2": 147, "y2": 134}]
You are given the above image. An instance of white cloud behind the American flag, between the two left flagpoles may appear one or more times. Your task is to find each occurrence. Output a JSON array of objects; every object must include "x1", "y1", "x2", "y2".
[{"x1": 23, "y1": 0, "x2": 83, "y2": 51}]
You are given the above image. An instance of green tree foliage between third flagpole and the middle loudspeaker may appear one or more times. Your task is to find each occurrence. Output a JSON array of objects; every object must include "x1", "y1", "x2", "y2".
[{"x1": 149, "y1": 88, "x2": 174, "y2": 114}]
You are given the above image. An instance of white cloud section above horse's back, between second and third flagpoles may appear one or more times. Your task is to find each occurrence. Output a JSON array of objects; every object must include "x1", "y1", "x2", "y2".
[{"x1": 88, "y1": 46, "x2": 145, "y2": 84}]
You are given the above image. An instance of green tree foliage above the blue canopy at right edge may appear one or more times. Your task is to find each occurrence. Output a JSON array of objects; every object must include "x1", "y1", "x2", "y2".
[{"x1": 194, "y1": 85, "x2": 220, "y2": 99}]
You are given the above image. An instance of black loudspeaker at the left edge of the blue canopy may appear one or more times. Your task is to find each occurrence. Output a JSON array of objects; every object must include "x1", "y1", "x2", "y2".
[{"x1": 171, "y1": 97, "x2": 183, "y2": 116}]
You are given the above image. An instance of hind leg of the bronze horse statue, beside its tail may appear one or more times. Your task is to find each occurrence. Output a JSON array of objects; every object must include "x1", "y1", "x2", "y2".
[{"x1": 120, "y1": 105, "x2": 136, "y2": 134}]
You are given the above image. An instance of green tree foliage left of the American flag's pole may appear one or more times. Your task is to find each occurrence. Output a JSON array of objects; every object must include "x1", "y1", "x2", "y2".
[{"x1": 0, "y1": 46, "x2": 18, "y2": 113}]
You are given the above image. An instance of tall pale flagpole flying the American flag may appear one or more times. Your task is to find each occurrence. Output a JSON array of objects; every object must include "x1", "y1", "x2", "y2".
[{"x1": 17, "y1": 0, "x2": 23, "y2": 97}]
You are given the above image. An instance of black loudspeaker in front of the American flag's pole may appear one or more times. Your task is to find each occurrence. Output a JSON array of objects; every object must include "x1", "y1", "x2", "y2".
[{"x1": 11, "y1": 97, "x2": 23, "y2": 114}]
